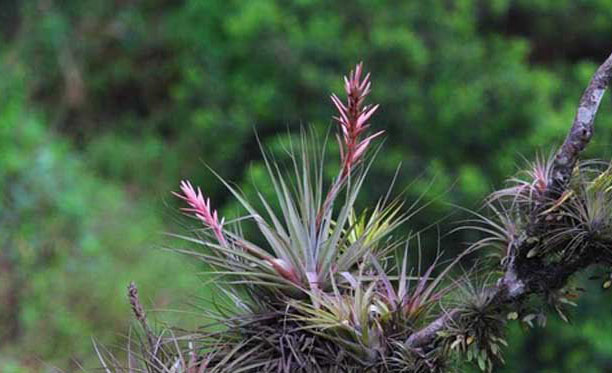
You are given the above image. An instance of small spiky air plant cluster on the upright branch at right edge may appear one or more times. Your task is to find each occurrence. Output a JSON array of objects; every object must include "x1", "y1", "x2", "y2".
[{"x1": 486, "y1": 157, "x2": 612, "y2": 272}]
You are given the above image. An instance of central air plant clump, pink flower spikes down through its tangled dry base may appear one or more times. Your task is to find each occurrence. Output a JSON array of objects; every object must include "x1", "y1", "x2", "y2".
[{"x1": 155, "y1": 64, "x2": 462, "y2": 372}]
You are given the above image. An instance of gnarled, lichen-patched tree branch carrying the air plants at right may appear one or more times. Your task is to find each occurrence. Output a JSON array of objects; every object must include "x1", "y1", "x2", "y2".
[{"x1": 406, "y1": 50, "x2": 612, "y2": 348}]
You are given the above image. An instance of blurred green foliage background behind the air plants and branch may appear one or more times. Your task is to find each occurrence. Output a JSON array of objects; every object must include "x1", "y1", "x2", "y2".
[{"x1": 0, "y1": 0, "x2": 612, "y2": 373}]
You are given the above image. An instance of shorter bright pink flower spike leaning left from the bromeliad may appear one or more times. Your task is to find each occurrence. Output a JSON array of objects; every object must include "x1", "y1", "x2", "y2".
[{"x1": 172, "y1": 180, "x2": 227, "y2": 246}]
